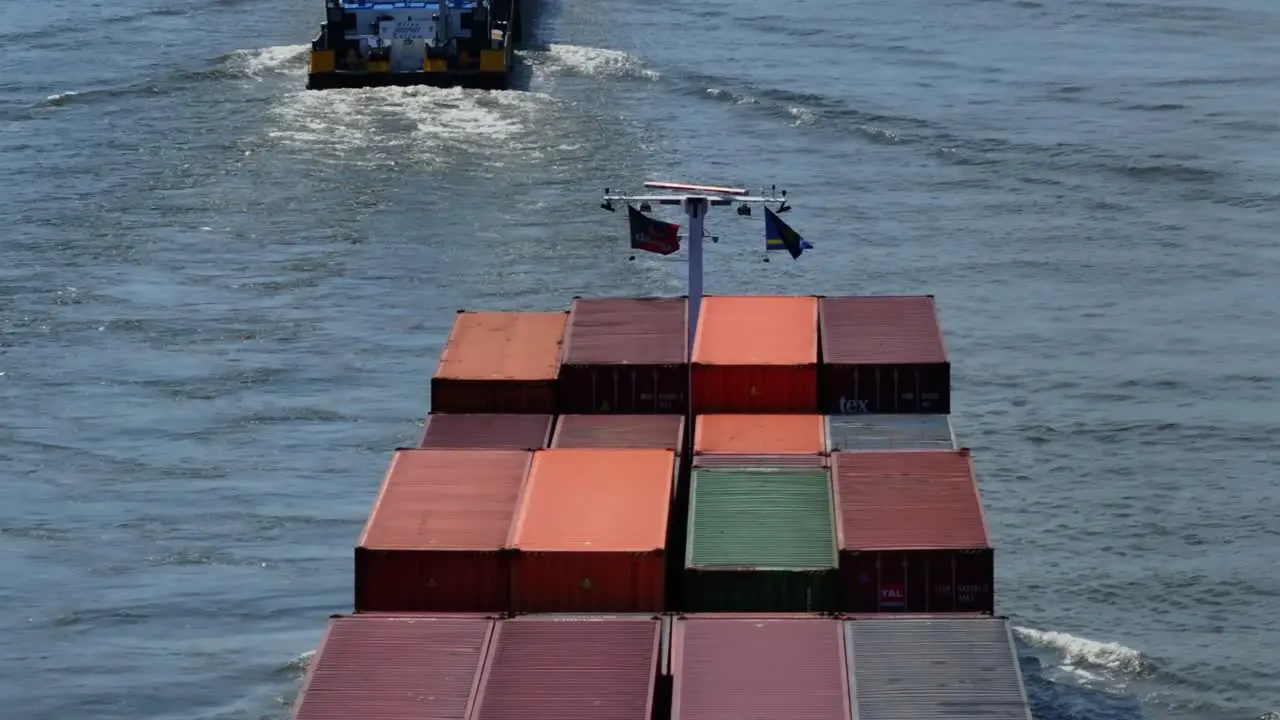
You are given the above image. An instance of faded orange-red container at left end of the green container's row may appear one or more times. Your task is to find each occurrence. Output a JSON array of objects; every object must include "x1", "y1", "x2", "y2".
[{"x1": 356, "y1": 450, "x2": 532, "y2": 612}]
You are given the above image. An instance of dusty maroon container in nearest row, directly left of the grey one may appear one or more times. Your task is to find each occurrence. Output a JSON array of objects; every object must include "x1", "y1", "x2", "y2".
[{"x1": 671, "y1": 616, "x2": 850, "y2": 720}]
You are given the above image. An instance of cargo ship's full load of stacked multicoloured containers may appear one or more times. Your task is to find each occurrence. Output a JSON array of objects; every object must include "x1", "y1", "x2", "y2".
[{"x1": 285, "y1": 185, "x2": 1032, "y2": 720}]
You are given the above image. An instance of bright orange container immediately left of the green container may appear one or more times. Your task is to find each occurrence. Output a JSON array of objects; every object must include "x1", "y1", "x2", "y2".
[{"x1": 511, "y1": 448, "x2": 676, "y2": 612}]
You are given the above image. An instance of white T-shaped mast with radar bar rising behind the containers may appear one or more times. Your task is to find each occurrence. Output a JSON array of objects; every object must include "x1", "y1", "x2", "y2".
[{"x1": 600, "y1": 182, "x2": 791, "y2": 352}]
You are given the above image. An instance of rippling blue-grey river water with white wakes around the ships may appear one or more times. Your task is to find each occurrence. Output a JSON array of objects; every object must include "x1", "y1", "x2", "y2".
[{"x1": 0, "y1": 0, "x2": 1280, "y2": 720}]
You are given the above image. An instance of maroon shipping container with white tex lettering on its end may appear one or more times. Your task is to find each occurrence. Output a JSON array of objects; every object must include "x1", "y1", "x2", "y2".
[{"x1": 818, "y1": 295, "x2": 951, "y2": 415}]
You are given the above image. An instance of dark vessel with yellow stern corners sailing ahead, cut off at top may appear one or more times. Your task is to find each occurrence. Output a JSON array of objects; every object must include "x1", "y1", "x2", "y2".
[{"x1": 307, "y1": 0, "x2": 522, "y2": 90}]
